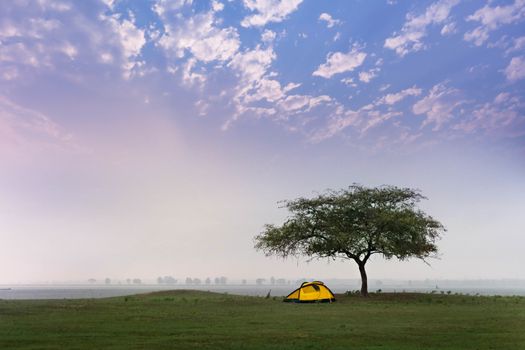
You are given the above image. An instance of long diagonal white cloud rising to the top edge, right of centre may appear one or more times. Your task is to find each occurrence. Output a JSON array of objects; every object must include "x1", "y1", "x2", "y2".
[{"x1": 384, "y1": 0, "x2": 459, "y2": 56}]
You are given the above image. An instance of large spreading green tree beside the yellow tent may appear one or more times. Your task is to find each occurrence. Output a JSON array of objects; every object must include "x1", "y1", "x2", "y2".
[{"x1": 255, "y1": 185, "x2": 445, "y2": 296}]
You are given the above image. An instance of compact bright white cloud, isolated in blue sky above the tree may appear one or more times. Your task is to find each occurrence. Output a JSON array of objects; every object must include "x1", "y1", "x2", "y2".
[{"x1": 312, "y1": 46, "x2": 366, "y2": 79}]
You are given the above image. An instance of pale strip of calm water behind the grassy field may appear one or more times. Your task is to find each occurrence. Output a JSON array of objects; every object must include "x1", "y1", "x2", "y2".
[{"x1": 0, "y1": 281, "x2": 525, "y2": 299}]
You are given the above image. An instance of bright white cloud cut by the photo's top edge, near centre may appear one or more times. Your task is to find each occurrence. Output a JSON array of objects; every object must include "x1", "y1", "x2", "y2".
[{"x1": 241, "y1": 0, "x2": 303, "y2": 27}]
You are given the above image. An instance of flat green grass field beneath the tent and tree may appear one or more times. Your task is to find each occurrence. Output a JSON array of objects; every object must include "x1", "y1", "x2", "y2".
[{"x1": 0, "y1": 291, "x2": 525, "y2": 349}]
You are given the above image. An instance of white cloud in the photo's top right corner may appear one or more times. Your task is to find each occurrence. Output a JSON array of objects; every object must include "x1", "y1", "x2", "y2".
[{"x1": 463, "y1": 0, "x2": 525, "y2": 46}]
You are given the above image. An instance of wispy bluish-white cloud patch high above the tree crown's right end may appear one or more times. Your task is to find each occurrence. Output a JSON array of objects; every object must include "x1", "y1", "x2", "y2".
[{"x1": 412, "y1": 83, "x2": 465, "y2": 130}]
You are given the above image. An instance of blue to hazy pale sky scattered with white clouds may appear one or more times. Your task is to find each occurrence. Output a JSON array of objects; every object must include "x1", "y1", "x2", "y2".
[{"x1": 0, "y1": 0, "x2": 525, "y2": 283}]
